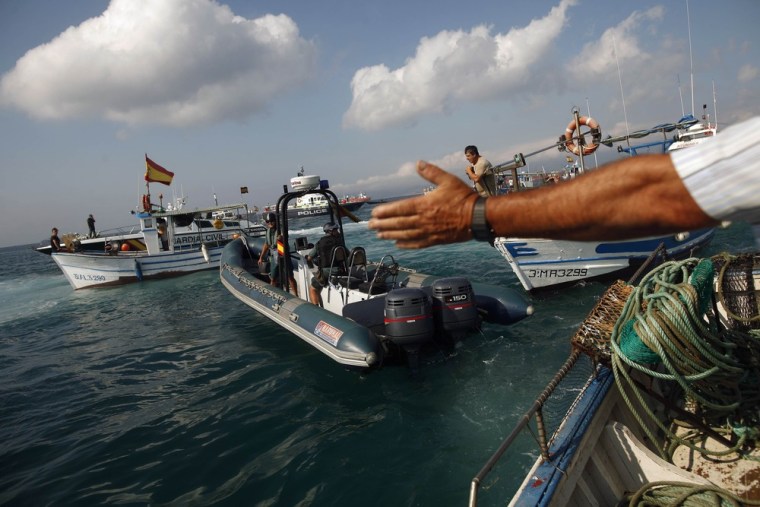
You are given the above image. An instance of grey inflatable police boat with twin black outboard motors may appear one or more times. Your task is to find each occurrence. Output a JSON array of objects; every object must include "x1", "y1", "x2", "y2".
[{"x1": 220, "y1": 178, "x2": 533, "y2": 369}]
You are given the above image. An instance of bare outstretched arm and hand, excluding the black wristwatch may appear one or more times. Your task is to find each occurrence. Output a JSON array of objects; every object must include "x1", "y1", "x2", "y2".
[{"x1": 369, "y1": 155, "x2": 719, "y2": 248}]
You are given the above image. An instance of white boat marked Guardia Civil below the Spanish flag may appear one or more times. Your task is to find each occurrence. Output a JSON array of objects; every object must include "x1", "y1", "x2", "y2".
[{"x1": 51, "y1": 204, "x2": 265, "y2": 289}]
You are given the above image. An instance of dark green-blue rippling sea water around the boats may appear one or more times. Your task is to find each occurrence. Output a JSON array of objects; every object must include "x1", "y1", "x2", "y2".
[{"x1": 0, "y1": 210, "x2": 753, "y2": 506}]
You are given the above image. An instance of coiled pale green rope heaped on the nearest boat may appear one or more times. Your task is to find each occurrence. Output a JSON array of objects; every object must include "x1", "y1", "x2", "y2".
[{"x1": 610, "y1": 258, "x2": 760, "y2": 461}]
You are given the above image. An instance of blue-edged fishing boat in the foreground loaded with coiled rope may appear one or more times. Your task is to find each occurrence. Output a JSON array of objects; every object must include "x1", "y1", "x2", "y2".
[{"x1": 469, "y1": 252, "x2": 760, "y2": 507}]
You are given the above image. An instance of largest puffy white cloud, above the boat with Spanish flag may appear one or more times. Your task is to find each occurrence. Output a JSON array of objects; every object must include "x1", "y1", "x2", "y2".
[{"x1": 0, "y1": 0, "x2": 316, "y2": 126}]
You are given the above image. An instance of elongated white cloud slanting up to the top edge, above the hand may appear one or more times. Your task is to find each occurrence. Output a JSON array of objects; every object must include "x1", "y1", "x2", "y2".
[{"x1": 343, "y1": 0, "x2": 576, "y2": 130}]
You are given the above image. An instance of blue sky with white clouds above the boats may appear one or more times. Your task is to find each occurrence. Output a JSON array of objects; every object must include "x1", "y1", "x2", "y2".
[{"x1": 0, "y1": 0, "x2": 760, "y2": 247}]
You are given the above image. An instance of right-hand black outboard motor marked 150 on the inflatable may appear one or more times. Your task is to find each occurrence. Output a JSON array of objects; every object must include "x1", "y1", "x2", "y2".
[{"x1": 432, "y1": 277, "x2": 479, "y2": 337}]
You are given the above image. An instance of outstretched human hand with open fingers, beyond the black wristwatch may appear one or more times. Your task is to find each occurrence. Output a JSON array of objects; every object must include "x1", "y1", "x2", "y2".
[{"x1": 369, "y1": 160, "x2": 478, "y2": 248}]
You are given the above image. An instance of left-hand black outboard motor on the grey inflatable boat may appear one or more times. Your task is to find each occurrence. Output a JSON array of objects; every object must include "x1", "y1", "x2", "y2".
[{"x1": 384, "y1": 288, "x2": 434, "y2": 370}]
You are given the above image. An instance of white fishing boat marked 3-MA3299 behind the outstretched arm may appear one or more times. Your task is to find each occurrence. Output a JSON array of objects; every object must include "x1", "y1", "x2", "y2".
[{"x1": 494, "y1": 110, "x2": 716, "y2": 291}]
